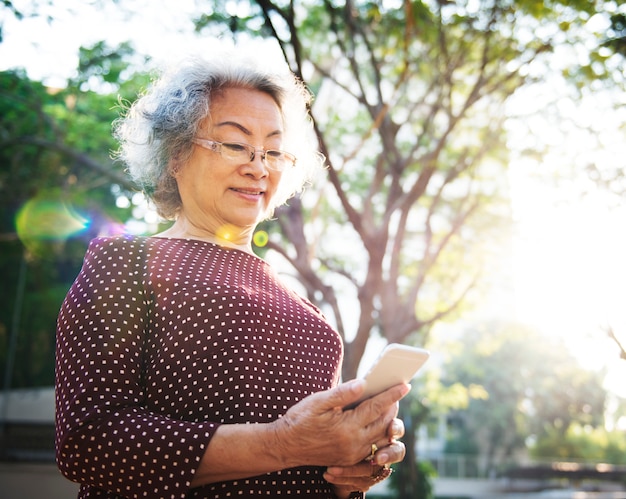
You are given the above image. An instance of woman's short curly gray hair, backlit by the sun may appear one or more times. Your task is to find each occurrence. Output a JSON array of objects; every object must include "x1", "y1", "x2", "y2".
[{"x1": 113, "y1": 51, "x2": 322, "y2": 219}]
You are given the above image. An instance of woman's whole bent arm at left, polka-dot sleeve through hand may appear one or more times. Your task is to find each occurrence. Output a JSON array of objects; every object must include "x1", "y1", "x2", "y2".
[{"x1": 56, "y1": 238, "x2": 408, "y2": 497}]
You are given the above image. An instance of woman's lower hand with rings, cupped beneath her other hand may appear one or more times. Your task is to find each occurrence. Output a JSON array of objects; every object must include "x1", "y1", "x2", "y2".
[{"x1": 324, "y1": 419, "x2": 406, "y2": 498}]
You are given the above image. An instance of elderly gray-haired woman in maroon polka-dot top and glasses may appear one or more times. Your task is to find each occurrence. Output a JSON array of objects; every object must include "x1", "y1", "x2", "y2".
[{"x1": 56, "y1": 47, "x2": 409, "y2": 498}]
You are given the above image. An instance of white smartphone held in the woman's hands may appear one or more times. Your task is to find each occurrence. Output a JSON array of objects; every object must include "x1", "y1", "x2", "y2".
[{"x1": 346, "y1": 343, "x2": 430, "y2": 409}]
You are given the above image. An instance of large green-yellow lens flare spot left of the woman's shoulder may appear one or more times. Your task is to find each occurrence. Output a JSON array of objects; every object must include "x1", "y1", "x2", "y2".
[{"x1": 15, "y1": 197, "x2": 89, "y2": 245}]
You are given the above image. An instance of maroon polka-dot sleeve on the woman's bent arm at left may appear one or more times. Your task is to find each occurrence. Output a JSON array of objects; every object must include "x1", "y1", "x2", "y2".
[{"x1": 55, "y1": 238, "x2": 217, "y2": 498}]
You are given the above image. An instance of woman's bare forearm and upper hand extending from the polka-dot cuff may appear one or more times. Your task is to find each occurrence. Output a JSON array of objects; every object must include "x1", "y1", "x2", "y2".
[{"x1": 192, "y1": 381, "x2": 409, "y2": 486}]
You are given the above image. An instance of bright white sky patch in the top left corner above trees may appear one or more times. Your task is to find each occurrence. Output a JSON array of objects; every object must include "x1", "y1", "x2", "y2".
[{"x1": 0, "y1": 0, "x2": 202, "y2": 87}]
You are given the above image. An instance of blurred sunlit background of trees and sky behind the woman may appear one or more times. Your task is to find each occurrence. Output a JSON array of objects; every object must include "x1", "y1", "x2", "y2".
[{"x1": 0, "y1": 0, "x2": 626, "y2": 498}]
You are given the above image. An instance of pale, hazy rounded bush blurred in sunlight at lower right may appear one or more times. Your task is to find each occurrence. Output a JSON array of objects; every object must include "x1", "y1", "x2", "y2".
[{"x1": 442, "y1": 324, "x2": 606, "y2": 474}]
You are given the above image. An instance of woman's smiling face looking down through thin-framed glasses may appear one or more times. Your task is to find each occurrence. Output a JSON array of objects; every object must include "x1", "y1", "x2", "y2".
[{"x1": 175, "y1": 88, "x2": 283, "y2": 235}]
